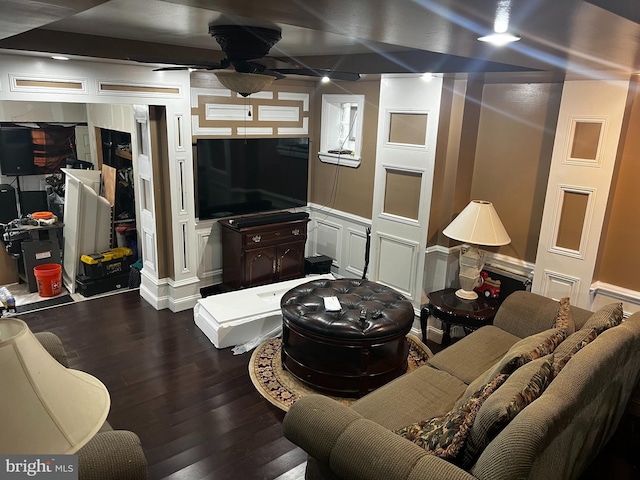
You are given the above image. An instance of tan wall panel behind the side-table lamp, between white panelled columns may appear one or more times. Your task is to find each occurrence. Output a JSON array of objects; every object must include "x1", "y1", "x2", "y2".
[{"x1": 471, "y1": 83, "x2": 562, "y2": 262}]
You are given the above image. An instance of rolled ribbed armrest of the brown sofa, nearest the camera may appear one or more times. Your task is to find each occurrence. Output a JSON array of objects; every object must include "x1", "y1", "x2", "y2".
[{"x1": 283, "y1": 395, "x2": 474, "y2": 480}]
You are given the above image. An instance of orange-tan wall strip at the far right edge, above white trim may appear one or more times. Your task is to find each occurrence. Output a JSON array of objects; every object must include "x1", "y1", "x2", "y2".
[{"x1": 594, "y1": 80, "x2": 640, "y2": 291}]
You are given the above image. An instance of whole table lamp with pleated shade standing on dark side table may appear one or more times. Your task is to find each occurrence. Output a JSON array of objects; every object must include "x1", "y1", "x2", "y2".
[{"x1": 442, "y1": 200, "x2": 511, "y2": 300}]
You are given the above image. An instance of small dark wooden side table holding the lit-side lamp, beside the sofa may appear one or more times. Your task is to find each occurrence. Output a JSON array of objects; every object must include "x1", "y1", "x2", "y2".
[{"x1": 420, "y1": 288, "x2": 500, "y2": 345}]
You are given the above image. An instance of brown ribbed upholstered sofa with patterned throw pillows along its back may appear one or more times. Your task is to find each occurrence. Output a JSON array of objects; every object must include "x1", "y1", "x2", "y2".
[{"x1": 283, "y1": 292, "x2": 640, "y2": 480}]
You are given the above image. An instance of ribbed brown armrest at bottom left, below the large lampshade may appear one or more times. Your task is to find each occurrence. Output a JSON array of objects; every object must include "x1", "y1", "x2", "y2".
[{"x1": 78, "y1": 430, "x2": 147, "y2": 480}]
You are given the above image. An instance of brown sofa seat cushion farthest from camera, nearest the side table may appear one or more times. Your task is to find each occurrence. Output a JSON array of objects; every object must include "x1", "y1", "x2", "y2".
[{"x1": 427, "y1": 325, "x2": 521, "y2": 384}]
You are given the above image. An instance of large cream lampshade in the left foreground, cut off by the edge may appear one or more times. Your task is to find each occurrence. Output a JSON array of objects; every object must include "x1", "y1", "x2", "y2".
[{"x1": 0, "y1": 318, "x2": 111, "y2": 455}]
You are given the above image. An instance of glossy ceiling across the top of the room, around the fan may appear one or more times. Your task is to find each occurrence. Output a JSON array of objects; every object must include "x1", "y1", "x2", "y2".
[{"x1": 0, "y1": 0, "x2": 640, "y2": 77}]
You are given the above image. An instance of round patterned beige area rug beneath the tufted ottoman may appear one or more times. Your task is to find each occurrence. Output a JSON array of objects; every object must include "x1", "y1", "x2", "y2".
[{"x1": 249, "y1": 334, "x2": 433, "y2": 412}]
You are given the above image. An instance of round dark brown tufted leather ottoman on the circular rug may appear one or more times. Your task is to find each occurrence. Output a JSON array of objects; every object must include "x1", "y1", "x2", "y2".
[{"x1": 280, "y1": 279, "x2": 414, "y2": 397}]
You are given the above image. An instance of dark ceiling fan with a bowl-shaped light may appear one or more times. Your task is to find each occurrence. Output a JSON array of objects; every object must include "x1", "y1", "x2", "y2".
[{"x1": 130, "y1": 25, "x2": 360, "y2": 97}]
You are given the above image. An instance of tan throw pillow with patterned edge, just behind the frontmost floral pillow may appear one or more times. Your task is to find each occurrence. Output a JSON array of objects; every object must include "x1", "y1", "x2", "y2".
[{"x1": 462, "y1": 355, "x2": 553, "y2": 468}]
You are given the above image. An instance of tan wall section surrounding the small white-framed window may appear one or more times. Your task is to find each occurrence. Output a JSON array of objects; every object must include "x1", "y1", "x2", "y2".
[{"x1": 309, "y1": 80, "x2": 380, "y2": 218}]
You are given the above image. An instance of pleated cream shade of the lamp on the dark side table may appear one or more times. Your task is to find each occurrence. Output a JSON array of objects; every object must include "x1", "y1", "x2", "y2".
[{"x1": 442, "y1": 200, "x2": 511, "y2": 246}]
